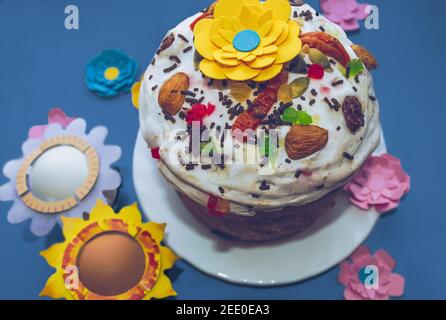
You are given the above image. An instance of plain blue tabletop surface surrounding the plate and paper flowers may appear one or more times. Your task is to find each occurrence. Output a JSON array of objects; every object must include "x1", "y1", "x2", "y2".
[{"x1": 0, "y1": 0, "x2": 446, "y2": 299}]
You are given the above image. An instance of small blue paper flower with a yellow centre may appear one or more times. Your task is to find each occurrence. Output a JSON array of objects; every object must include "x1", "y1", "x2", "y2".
[{"x1": 85, "y1": 49, "x2": 138, "y2": 97}]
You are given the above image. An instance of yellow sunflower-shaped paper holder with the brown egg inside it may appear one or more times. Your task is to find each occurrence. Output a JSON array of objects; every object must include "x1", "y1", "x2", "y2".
[{"x1": 40, "y1": 200, "x2": 177, "y2": 300}]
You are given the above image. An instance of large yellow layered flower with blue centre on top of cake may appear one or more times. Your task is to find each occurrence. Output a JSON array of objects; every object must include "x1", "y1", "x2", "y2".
[{"x1": 194, "y1": 0, "x2": 302, "y2": 81}]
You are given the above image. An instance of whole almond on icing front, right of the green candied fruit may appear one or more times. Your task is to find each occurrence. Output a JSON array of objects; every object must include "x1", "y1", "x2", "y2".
[{"x1": 285, "y1": 125, "x2": 328, "y2": 160}]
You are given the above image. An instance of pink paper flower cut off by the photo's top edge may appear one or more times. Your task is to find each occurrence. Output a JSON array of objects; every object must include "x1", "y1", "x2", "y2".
[{"x1": 321, "y1": 0, "x2": 368, "y2": 31}]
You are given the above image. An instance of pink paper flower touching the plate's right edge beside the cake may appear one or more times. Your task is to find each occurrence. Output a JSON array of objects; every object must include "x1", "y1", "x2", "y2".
[{"x1": 345, "y1": 154, "x2": 410, "y2": 213}]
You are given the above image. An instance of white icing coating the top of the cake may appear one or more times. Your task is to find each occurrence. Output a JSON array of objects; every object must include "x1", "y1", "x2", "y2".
[{"x1": 139, "y1": 5, "x2": 381, "y2": 215}]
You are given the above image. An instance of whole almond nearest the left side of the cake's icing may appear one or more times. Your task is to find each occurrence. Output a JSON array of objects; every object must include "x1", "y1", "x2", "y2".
[{"x1": 158, "y1": 72, "x2": 189, "y2": 116}]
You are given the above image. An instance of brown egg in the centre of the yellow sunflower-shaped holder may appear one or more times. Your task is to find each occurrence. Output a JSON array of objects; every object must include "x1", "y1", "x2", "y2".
[{"x1": 77, "y1": 232, "x2": 146, "y2": 296}]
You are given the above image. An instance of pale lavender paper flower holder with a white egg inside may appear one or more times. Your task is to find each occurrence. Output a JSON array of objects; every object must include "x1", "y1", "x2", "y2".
[{"x1": 0, "y1": 109, "x2": 121, "y2": 236}]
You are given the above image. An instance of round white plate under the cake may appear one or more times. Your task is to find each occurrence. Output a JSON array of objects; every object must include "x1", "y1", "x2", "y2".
[{"x1": 133, "y1": 134, "x2": 386, "y2": 286}]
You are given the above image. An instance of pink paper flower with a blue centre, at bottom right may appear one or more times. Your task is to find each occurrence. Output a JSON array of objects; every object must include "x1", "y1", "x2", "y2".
[{"x1": 338, "y1": 246, "x2": 405, "y2": 300}]
